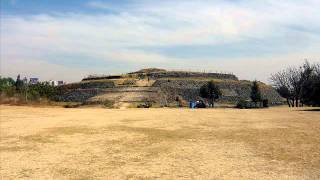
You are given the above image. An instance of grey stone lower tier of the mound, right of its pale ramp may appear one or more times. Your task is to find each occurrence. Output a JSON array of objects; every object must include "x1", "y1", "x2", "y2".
[{"x1": 153, "y1": 79, "x2": 282, "y2": 105}]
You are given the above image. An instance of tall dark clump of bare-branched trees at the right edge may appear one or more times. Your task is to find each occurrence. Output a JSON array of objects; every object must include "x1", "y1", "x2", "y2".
[{"x1": 271, "y1": 61, "x2": 320, "y2": 107}]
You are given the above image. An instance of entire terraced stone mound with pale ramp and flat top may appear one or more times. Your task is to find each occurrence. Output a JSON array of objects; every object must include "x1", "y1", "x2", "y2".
[{"x1": 57, "y1": 69, "x2": 283, "y2": 106}]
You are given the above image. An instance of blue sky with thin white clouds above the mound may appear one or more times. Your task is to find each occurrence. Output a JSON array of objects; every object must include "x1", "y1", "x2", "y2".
[{"x1": 0, "y1": 0, "x2": 320, "y2": 82}]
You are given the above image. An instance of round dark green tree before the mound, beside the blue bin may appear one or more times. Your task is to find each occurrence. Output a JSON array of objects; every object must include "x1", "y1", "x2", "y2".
[{"x1": 200, "y1": 81, "x2": 222, "y2": 107}]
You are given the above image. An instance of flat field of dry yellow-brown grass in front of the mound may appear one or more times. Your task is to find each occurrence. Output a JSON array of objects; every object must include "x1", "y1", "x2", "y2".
[{"x1": 0, "y1": 106, "x2": 320, "y2": 179}]
